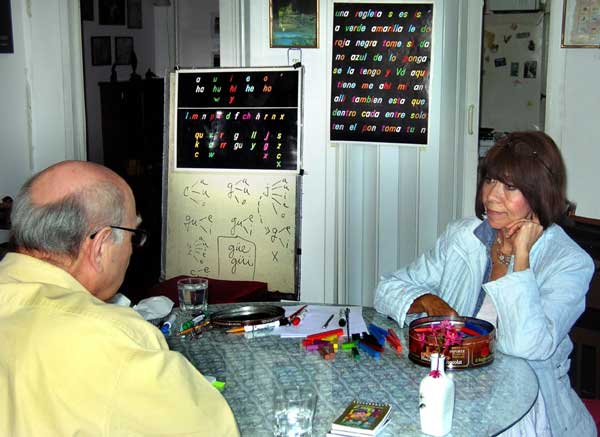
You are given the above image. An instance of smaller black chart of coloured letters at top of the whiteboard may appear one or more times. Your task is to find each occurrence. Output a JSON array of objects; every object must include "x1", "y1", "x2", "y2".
[{"x1": 175, "y1": 67, "x2": 302, "y2": 172}]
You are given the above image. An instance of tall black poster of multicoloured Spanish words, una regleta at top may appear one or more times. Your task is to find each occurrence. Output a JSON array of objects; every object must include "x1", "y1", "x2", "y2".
[{"x1": 329, "y1": 2, "x2": 433, "y2": 146}]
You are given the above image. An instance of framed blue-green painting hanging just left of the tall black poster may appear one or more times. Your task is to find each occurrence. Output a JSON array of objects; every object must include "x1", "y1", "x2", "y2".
[{"x1": 269, "y1": 0, "x2": 319, "y2": 49}]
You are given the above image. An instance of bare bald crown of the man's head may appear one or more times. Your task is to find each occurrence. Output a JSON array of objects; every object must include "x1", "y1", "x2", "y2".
[{"x1": 31, "y1": 161, "x2": 128, "y2": 205}]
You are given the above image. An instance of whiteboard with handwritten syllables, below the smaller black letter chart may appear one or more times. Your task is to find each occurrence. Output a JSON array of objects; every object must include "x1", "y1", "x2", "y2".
[{"x1": 163, "y1": 75, "x2": 300, "y2": 298}]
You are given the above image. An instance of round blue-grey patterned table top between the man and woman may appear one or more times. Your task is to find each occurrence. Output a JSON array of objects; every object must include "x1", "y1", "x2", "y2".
[{"x1": 167, "y1": 302, "x2": 538, "y2": 437}]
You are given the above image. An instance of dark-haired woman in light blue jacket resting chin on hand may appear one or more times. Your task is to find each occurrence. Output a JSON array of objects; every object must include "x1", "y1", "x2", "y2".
[{"x1": 375, "y1": 132, "x2": 597, "y2": 437}]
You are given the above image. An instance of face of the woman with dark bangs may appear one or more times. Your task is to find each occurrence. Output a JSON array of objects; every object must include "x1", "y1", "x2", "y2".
[{"x1": 481, "y1": 178, "x2": 532, "y2": 229}]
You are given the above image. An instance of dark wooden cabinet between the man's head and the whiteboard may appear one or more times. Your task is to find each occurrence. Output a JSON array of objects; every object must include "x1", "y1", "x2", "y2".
[{"x1": 99, "y1": 78, "x2": 164, "y2": 302}]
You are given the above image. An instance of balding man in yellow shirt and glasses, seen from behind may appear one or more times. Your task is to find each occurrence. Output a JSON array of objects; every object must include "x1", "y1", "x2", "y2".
[{"x1": 0, "y1": 161, "x2": 239, "y2": 437}]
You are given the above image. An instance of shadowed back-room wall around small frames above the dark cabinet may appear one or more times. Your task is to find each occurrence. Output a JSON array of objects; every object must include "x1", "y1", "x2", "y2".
[{"x1": 82, "y1": 0, "x2": 157, "y2": 163}]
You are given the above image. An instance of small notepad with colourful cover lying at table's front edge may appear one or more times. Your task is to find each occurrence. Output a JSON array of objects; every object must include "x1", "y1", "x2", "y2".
[{"x1": 331, "y1": 400, "x2": 391, "y2": 435}]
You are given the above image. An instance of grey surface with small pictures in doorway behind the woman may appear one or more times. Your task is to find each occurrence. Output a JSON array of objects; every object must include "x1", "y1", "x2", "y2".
[{"x1": 479, "y1": 1, "x2": 549, "y2": 157}]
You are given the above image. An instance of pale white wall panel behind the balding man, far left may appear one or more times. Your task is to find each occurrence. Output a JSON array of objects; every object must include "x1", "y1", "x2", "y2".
[{"x1": 0, "y1": 0, "x2": 85, "y2": 196}]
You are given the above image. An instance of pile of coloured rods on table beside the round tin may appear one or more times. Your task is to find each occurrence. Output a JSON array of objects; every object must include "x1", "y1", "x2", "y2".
[{"x1": 302, "y1": 323, "x2": 402, "y2": 360}]
